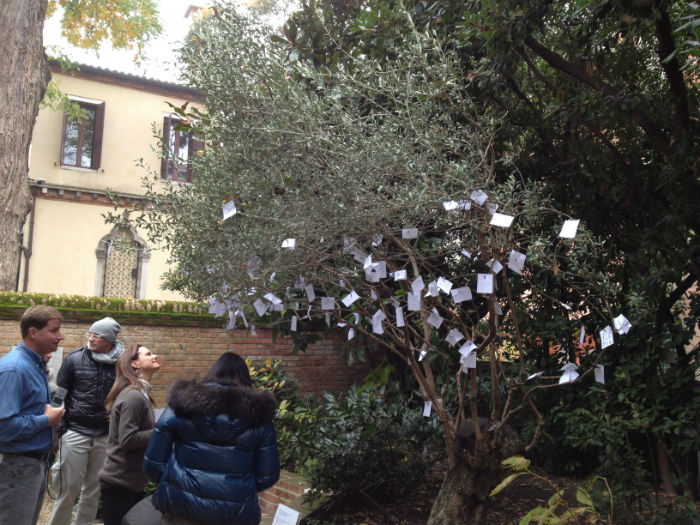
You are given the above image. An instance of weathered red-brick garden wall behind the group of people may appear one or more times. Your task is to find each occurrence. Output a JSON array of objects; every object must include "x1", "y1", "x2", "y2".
[{"x1": 0, "y1": 314, "x2": 368, "y2": 407}]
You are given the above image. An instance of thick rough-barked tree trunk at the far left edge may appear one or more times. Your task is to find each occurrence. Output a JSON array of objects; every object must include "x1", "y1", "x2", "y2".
[{"x1": 0, "y1": 0, "x2": 51, "y2": 290}]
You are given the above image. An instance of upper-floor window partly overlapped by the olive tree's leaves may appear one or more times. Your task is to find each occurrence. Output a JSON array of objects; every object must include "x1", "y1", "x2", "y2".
[{"x1": 160, "y1": 115, "x2": 204, "y2": 182}]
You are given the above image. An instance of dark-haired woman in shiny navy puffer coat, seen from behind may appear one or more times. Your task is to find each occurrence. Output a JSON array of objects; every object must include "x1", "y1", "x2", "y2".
[{"x1": 143, "y1": 352, "x2": 280, "y2": 524}]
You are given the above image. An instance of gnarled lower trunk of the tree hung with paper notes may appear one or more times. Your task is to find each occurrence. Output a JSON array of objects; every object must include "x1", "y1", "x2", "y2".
[{"x1": 428, "y1": 422, "x2": 523, "y2": 525}]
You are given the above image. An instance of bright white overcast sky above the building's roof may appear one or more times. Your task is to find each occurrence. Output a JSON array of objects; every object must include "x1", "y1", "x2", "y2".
[{"x1": 44, "y1": 0, "x2": 197, "y2": 82}]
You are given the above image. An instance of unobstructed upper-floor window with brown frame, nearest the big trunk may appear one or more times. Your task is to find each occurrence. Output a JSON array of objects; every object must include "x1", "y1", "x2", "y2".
[{"x1": 61, "y1": 97, "x2": 105, "y2": 170}]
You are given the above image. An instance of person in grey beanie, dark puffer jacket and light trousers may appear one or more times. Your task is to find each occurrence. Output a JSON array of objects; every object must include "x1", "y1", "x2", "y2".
[{"x1": 49, "y1": 317, "x2": 124, "y2": 525}]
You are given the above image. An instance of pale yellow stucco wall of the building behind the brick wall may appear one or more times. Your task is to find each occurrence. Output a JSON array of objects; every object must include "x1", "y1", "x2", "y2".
[{"x1": 18, "y1": 68, "x2": 201, "y2": 300}]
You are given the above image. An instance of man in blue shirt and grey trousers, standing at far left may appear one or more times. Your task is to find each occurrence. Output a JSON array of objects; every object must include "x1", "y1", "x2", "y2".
[{"x1": 0, "y1": 305, "x2": 65, "y2": 525}]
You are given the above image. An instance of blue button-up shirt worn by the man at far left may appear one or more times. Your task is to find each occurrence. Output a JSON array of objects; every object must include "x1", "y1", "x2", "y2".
[{"x1": 0, "y1": 342, "x2": 53, "y2": 452}]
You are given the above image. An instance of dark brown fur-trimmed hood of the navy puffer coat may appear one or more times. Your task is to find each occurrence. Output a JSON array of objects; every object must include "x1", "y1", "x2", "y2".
[{"x1": 168, "y1": 379, "x2": 277, "y2": 427}]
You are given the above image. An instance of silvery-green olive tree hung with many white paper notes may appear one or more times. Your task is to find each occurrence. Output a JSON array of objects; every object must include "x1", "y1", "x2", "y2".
[{"x1": 110, "y1": 6, "x2": 628, "y2": 523}]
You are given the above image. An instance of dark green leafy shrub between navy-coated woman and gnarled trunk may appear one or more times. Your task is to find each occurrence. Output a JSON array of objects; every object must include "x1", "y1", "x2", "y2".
[{"x1": 303, "y1": 376, "x2": 439, "y2": 500}]
